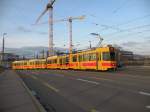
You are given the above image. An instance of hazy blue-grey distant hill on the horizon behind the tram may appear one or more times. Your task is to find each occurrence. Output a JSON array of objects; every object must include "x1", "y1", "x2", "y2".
[{"x1": 5, "y1": 46, "x2": 68, "y2": 57}]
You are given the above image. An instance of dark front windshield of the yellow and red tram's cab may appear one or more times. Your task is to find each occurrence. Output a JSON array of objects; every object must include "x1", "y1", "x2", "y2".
[{"x1": 103, "y1": 52, "x2": 115, "y2": 61}]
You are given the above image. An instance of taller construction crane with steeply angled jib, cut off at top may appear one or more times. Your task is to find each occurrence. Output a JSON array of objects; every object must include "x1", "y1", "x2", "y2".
[{"x1": 35, "y1": 0, "x2": 56, "y2": 55}]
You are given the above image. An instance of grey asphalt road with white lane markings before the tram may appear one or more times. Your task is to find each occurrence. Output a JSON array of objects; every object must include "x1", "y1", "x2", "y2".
[{"x1": 14, "y1": 67, "x2": 150, "y2": 112}]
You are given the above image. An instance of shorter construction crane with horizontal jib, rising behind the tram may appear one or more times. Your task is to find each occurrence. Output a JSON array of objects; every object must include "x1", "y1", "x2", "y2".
[{"x1": 37, "y1": 15, "x2": 86, "y2": 53}]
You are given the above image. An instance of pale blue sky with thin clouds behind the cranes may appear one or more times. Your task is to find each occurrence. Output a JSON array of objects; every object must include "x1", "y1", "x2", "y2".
[{"x1": 0, "y1": 0, "x2": 150, "y2": 55}]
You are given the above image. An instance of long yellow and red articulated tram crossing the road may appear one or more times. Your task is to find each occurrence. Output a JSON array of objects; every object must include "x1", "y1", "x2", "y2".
[{"x1": 12, "y1": 46, "x2": 116, "y2": 71}]
